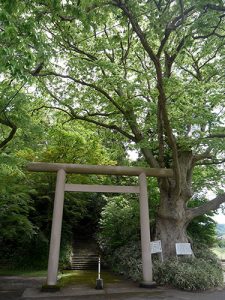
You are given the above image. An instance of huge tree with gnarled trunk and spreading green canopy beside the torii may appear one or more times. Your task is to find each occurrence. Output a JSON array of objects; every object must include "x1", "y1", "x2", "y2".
[{"x1": 0, "y1": 0, "x2": 225, "y2": 256}]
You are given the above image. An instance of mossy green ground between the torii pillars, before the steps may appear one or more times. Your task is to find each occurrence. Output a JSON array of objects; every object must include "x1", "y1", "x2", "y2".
[{"x1": 58, "y1": 270, "x2": 122, "y2": 287}]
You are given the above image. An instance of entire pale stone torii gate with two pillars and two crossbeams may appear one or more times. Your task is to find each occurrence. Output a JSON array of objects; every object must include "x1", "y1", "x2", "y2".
[{"x1": 27, "y1": 162, "x2": 173, "y2": 287}]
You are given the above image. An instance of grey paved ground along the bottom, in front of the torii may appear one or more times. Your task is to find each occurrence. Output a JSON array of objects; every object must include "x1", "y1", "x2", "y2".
[{"x1": 0, "y1": 276, "x2": 225, "y2": 300}]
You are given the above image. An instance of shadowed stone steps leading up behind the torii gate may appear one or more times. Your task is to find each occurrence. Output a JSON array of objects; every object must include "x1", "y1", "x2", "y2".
[{"x1": 71, "y1": 239, "x2": 98, "y2": 270}]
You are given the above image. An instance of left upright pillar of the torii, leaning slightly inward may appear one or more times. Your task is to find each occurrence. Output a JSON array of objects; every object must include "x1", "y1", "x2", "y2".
[{"x1": 47, "y1": 169, "x2": 66, "y2": 285}]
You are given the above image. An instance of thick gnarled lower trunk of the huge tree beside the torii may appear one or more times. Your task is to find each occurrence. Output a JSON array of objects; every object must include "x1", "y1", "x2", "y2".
[{"x1": 156, "y1": 152, "x2": 193, "y2": 259}]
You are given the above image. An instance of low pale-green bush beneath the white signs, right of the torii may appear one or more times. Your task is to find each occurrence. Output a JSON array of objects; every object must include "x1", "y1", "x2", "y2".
[{"x1": 153, "y1": 258, "x2": 223, "y2": 291}]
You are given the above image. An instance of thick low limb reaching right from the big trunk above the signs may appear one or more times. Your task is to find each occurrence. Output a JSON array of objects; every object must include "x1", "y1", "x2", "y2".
[{"x1": 186, "y1": 194, "x2": 225, "y2": 220}]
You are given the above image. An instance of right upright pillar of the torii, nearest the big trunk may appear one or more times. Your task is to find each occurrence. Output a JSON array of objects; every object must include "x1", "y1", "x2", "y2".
[{"x1": 139, "y1": 173, "x2": 155, "y2": 287}]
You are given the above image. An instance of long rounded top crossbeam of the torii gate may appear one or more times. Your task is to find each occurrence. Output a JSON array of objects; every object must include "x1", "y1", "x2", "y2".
[{"x1": 27, "y1": 162, "x2": 173, "y2": 177}]
